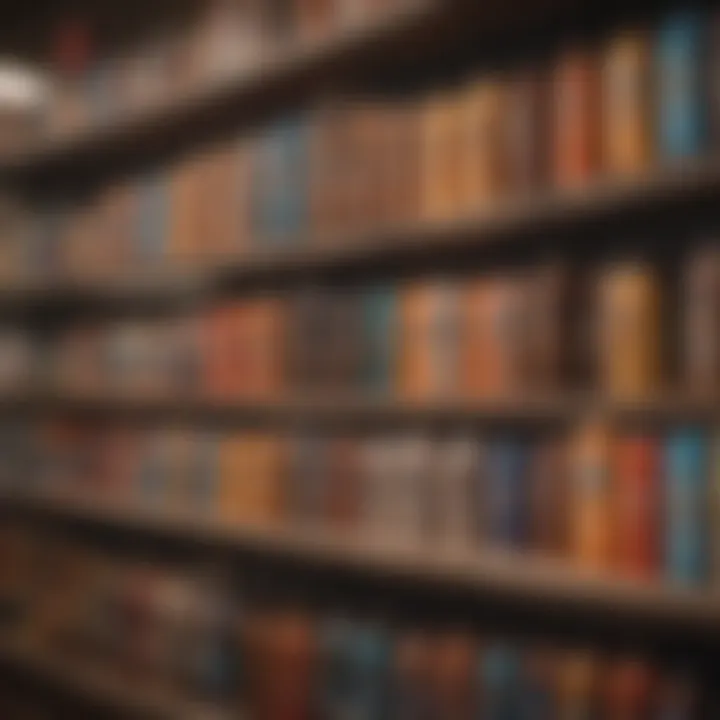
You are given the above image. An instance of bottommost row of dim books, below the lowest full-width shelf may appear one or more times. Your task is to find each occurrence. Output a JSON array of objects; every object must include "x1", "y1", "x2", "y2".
[{"x1": 0, "y1": 531, "x2": 702, "y2": 720}]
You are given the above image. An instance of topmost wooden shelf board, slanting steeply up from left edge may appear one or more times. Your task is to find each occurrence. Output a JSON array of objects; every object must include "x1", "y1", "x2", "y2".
[{"x1": 0, "y1": 0, "x2": 430, "y2": 183}]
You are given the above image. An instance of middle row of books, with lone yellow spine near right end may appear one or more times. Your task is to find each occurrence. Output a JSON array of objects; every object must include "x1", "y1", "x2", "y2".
[{"x1": 0, "y1": 255, "x2": 720, "y2": 402}]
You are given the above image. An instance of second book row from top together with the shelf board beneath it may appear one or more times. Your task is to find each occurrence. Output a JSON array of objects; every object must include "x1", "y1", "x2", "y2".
[{"x1": 2, "y1": 3, "x2": 718, "y2": 306}]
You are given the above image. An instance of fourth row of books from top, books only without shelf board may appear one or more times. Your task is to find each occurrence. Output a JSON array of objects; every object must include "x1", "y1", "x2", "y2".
[{"x1": 0, "y1": 423, "x2": 720, "y2": 586}]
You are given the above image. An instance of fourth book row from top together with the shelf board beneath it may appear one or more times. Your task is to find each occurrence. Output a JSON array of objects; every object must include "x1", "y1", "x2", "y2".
[{"x1": 1, "y1": 404, "x2": 718, "y2": 623}]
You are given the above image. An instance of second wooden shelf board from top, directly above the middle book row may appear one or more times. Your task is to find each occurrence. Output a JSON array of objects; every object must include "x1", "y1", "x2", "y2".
[{"x1": 0, "y1": 160, "x2": 720, "y2": 311}]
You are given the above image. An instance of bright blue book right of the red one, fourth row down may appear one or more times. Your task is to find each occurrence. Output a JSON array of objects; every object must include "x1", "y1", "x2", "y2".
[{"x1": 665, "y1": 432, "x2": 709, "y2": 585}]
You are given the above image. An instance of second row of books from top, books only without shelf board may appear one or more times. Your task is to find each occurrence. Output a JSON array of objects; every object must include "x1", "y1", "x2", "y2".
[{"x1": 0, "y1": 6, "x2": 720, "y2": 277}]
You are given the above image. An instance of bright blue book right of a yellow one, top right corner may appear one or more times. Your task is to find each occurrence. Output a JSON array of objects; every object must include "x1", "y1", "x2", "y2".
[{"x1": 657, "y1": 12, "x2": 708, "y2": 159}]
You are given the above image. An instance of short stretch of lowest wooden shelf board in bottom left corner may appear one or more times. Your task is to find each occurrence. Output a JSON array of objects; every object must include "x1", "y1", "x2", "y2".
[{"x1": 0, "y1": 636, "x2": 231, "y2": 720}]
